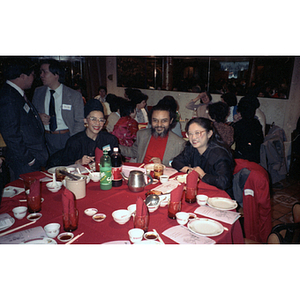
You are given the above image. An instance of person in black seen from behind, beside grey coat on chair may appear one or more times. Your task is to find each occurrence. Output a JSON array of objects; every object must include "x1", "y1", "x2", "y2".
[{"x1": 232, "y1": 96, "x2": 264, "y2": 163}]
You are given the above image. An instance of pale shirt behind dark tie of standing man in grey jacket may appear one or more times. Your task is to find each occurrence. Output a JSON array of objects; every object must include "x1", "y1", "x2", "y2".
[{"x1": 45, "y1": 84, "x2": 68, "y2": 130}]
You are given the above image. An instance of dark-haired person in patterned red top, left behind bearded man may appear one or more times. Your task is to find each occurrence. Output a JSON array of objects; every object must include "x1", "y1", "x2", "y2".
[{"x1": 112, "y1": 102, "x2": 139, "y2": 147}]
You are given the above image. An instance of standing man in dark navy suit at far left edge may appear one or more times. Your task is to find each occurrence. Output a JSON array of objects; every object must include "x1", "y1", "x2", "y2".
[{"x1": 0, "y1": 59, "x2": 48, "y2": 181}]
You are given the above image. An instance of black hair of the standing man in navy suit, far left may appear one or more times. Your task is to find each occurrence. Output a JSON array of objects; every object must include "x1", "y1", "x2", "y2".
[{"x1": 3, "y1": 57, "x2": 35, "y2": 80}]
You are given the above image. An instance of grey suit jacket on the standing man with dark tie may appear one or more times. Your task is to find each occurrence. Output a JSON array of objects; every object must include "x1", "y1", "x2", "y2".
[{"x1": 32, "y1": 85, "x2": 85, "y2": 136}]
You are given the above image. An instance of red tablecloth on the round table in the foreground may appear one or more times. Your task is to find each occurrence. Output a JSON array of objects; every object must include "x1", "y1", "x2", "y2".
[{"x1": 0, "y1": 166, "x2": 244, "y2": 244}]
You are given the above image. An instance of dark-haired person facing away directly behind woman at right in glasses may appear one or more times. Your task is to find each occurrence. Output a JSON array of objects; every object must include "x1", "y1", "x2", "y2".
[{"x1": 208, "y1": 101, "x2": 234, "y2": 147}]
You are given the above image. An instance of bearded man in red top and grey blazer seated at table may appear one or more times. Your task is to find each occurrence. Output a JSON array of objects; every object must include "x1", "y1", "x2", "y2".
[{"x1": 120, "y1": 104, "x2": 185, "y2": 166}]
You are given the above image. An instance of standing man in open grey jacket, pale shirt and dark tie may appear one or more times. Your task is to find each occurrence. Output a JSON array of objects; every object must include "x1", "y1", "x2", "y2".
[{"x1": 32, "y1": 59, "x2": 84, "y2": 155}]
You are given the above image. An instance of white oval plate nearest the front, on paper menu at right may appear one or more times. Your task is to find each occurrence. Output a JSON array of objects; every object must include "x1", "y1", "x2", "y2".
[{"x1": 188, "y1": 218, "x2": 224, "y2": 236}]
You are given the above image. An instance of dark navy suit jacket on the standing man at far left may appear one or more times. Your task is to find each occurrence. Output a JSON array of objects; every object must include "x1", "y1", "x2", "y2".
[{"x1": 0, "y1": 83, "x2": 48, "y2": 174}]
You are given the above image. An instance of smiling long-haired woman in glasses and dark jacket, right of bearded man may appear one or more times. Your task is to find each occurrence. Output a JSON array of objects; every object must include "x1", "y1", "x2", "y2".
[{"x1": 172, "y1": 118, "x2": 234, "y2": 197}]
